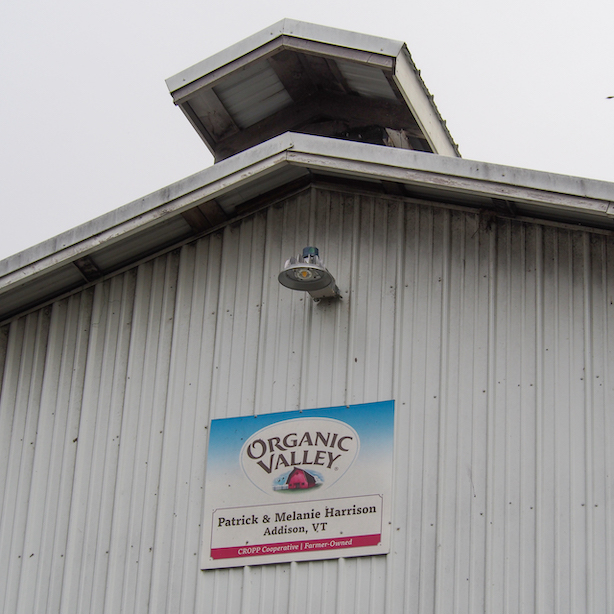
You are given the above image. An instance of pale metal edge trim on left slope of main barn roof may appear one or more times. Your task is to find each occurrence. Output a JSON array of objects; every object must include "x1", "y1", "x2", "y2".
[{"x1": 0, "y1": 133, "x2": 293, "y2": 288}]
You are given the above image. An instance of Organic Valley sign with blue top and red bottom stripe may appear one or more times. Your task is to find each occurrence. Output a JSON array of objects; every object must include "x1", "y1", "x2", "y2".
[{"x1": 201, "y1": 401, "x2": 394, "y2": 569}]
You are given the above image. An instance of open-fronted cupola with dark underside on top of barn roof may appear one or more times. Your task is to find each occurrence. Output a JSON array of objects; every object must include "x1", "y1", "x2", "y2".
[{"x1": 167, "y1": 19, "x2": 460, "y2": 162}]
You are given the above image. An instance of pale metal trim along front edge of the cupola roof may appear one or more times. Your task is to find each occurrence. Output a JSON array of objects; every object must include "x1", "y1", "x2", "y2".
[{"x1": 166, "y1": 18, "x2": 404, "y2": 92}]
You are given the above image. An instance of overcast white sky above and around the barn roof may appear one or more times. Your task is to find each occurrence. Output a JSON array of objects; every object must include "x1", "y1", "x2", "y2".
[{"x1": 0, "y1": 0, "x2": 614, "y2": 259}]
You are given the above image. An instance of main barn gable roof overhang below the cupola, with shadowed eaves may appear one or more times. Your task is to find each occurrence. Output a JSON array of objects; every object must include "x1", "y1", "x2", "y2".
[{"x1": 0, "y1": 133, "x2": 614, "y2": 328}]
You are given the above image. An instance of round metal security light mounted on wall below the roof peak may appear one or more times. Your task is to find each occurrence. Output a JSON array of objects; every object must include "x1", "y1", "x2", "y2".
[{"x1": 278, "y1": 247, "x2": 341, "y2": 300}]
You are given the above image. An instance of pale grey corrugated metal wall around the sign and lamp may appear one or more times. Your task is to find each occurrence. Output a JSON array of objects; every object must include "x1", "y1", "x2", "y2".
[{"x1": 0, "y1": 190, "x2": 614, "y2": 614}]
